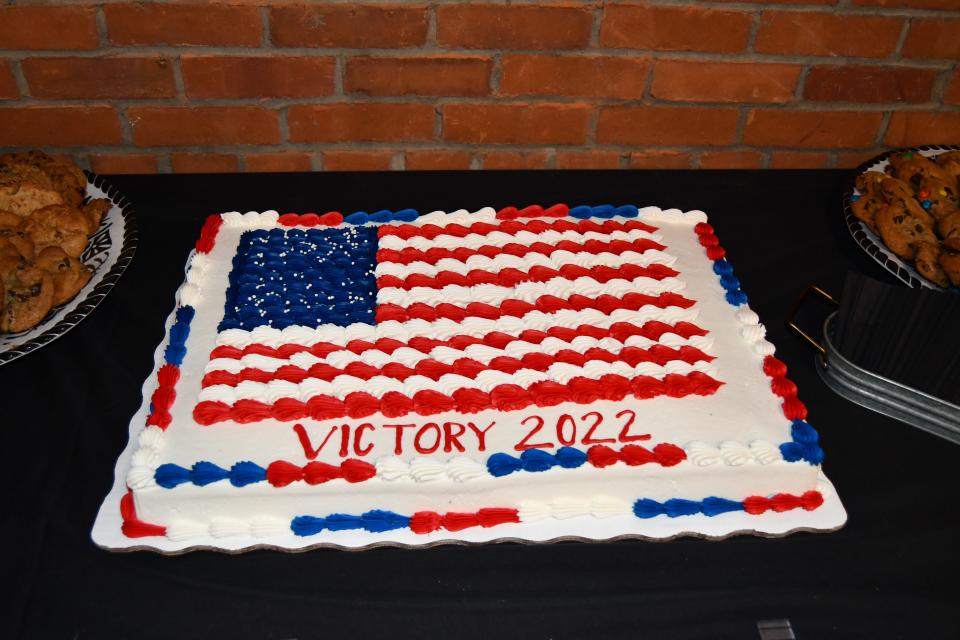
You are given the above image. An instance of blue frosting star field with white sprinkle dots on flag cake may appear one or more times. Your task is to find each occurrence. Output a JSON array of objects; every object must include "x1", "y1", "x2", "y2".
[{"x1": 218, "y1": 226, "x2": 377, "y2": 331}]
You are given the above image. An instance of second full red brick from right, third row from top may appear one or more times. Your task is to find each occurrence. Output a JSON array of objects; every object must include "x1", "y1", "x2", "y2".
[{"x1": 597, "y1": 107, "x2": 738, "y2": 145}]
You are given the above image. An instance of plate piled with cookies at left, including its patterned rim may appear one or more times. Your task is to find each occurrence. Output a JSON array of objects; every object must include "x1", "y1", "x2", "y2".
[{"x1": 0, "y1": 151, "x2": 137, "y2": 364}]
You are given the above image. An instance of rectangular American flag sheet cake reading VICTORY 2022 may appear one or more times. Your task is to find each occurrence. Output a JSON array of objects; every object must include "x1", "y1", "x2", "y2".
[{"x1": 107, "y1": 204, "x2": 840, "y2": 546}]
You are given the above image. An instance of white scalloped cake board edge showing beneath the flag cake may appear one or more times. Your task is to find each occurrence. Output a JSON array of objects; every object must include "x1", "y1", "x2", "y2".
[{"x1": 92, "y1": 206, "x2": 847, "y2": 555}]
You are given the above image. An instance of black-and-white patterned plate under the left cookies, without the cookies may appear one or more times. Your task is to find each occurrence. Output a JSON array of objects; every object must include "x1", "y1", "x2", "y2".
[{"x1": 0, "y1": 171, "x2": 137, "y2": 365}]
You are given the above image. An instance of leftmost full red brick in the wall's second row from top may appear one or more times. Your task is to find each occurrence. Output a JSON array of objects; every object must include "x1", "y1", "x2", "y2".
[{"x1": 21, "y1": 57, "x2": 177, "y2": 100}]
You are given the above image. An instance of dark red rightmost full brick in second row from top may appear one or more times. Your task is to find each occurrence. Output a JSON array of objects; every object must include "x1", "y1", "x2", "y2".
[{"x1": 803, "y1": 65, "x2": 940, "y2": 102}]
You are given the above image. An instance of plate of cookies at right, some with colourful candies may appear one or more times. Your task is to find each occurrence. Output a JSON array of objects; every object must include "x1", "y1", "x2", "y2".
[{"x1": 843, "y1": 145, "x2": 960, "y2": 291}]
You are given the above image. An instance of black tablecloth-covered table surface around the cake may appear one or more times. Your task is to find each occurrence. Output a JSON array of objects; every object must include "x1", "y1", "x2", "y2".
[{"x1": 0, "y1": 170, "x2": 960, "y2": 640}]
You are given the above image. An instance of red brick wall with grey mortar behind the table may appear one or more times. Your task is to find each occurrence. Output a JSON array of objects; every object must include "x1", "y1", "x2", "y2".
[{"x1": 0, "y1": 0, "x2": 960, "y2": 173}]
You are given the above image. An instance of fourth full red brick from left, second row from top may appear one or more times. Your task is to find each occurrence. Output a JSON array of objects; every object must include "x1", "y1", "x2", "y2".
[{"x1": 500, "y1": 55, "x2": 650, "y2": 100}]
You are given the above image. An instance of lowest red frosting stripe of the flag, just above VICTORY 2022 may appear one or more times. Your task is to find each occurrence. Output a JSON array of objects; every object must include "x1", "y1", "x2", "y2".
[{"x1": 193, "y1": 371, "x2": 723, "y2": 424}]
